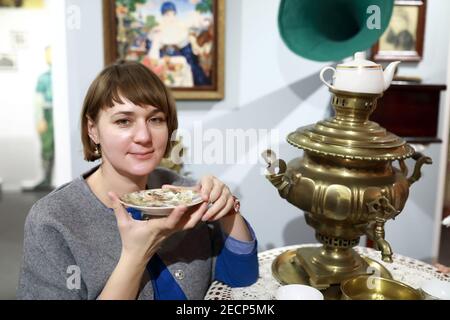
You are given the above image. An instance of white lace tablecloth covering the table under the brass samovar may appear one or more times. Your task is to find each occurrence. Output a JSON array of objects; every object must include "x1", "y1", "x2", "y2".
[{"x1": 205, "y1": 244, "x2": 450, "y2": 300}]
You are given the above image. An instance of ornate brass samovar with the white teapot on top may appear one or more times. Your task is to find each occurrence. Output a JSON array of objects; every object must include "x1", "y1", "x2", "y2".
[{"x1": 263, "y1": 53, "x2": 431, "y2": 289}]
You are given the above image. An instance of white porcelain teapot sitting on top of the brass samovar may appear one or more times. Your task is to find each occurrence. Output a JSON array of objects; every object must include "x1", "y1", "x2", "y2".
[{"x1": 320, "y1": 51, "x2": 400, "y2": 94}]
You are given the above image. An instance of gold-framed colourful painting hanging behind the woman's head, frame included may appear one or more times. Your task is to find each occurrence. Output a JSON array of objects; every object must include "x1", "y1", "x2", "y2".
[{"x1": 103, "y1": 0, "x2": 225, "y2": 100}]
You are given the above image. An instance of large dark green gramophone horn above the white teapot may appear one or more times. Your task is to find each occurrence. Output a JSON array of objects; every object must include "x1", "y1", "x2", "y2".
[{"x1": 278, "y1": 0, "x2": 394, "y2": 61}]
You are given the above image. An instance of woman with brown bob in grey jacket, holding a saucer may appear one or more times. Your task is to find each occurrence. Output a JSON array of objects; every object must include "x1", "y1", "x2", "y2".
[{"x1": 18, "y1": 62, "x2": 258, "y2": 299}]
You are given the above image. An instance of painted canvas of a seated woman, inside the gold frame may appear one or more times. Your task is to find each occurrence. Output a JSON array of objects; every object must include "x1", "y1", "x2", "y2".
[{"x1": 116, "y1": 0, "x2": 215, "y2": 88}]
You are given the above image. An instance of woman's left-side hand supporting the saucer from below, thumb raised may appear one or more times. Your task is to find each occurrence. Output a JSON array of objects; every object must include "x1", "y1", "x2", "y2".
[{"x1": 108, "y1": 192, "x2": 208, "y2": 266}]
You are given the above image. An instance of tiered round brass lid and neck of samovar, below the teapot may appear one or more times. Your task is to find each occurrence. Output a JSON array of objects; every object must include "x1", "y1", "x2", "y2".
[{"x1": 287, "y1": 90, "x2": 414, "y2": 161}]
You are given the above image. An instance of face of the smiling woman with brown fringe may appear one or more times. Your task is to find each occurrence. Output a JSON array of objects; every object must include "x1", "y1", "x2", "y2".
[{"x1": 88, "y1": 96, "x2": 169, "y2": 176}]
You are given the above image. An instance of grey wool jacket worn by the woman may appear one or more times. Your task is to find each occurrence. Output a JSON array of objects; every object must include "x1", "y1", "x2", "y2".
[{"x1": 17, "y1": 168, "x2": 223, "y2": 299}]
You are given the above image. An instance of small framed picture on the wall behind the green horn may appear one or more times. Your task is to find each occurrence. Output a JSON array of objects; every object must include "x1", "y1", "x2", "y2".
[{"x1": 372, "y1": 0, "x2": 426, "y2": 62}]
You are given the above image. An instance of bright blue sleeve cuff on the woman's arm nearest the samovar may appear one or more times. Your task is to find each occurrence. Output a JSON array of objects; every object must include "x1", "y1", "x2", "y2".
[{"x1": 215, "y1": 221, "x2": 259, "y2": 288}]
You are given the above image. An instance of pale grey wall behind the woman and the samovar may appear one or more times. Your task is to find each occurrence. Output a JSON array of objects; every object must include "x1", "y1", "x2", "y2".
[{"x1": 0, "y1": 0, "x2": 450, "y2": 259}]
